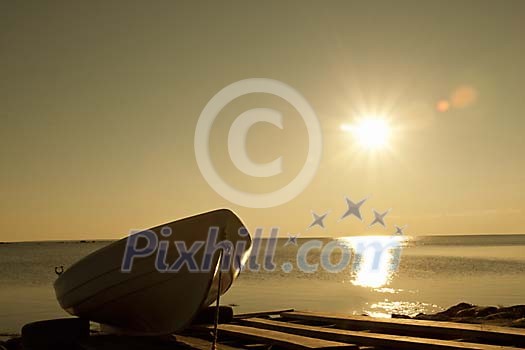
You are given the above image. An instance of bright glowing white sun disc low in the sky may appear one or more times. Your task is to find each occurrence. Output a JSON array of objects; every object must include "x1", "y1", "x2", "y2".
[{"x1": 341, "y1": 116, "x2": 391, "y2": 150}]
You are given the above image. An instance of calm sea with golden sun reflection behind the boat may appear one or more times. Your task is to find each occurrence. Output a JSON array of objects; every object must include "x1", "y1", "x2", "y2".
[{"x1": 0, "y1": 235, "x2": 525, "y2": 334}]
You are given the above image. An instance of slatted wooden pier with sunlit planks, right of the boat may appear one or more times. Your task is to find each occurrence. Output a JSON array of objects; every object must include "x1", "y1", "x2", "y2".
[{"x1": 174, "y1": 310, "x2": 525, "y2": 350}]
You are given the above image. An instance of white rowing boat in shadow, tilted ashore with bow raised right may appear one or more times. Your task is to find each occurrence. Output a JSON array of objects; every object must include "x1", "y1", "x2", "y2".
[{"x1": 54, "y1": 209, "x2": 251, "y2": 335}]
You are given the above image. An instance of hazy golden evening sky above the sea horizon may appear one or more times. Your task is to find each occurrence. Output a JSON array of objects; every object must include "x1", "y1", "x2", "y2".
[{"x1": 0, "y1": 0, "x2": 525, "y2": 241}]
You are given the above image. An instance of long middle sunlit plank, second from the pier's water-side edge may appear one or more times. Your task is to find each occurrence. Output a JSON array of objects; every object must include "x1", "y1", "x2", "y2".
[{"x1": 241, "y1": 318, "x2": 517, "y2": 350}]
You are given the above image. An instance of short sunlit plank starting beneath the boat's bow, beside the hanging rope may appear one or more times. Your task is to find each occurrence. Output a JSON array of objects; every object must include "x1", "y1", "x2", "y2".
[{"x1": 206, "y1": 324, "x2": 358, "y2": 350}]
